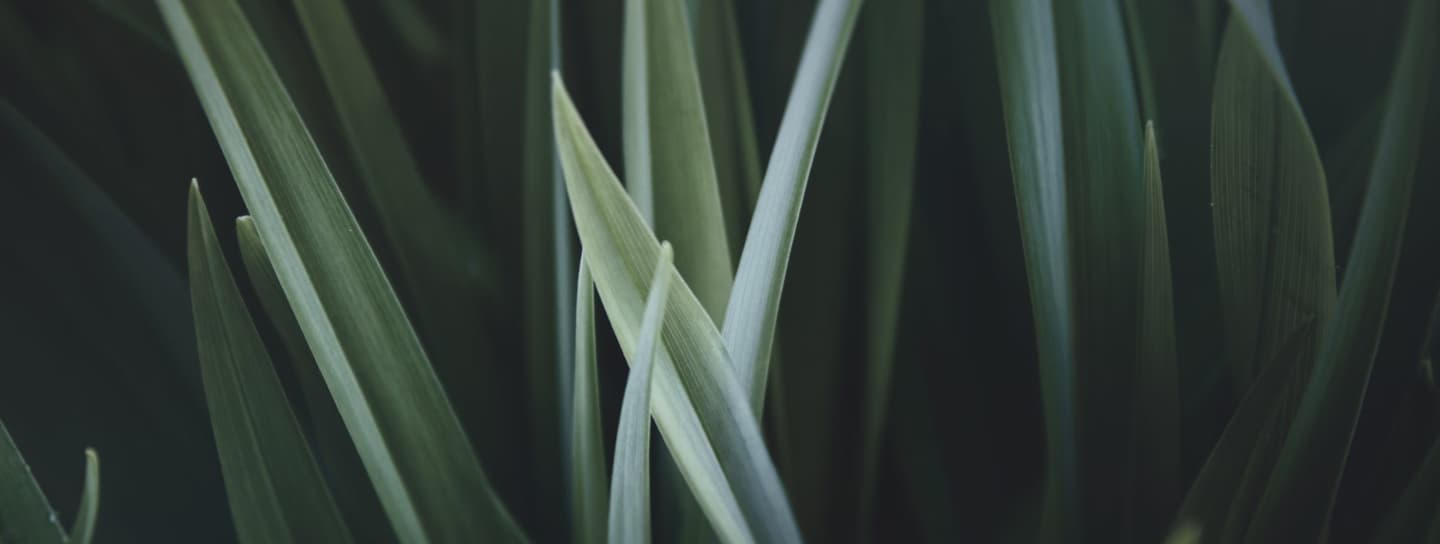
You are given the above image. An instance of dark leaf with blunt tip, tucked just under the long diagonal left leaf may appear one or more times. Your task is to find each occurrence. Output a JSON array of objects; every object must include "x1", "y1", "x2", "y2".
[{"x1": 235, "y1": 216, "x2": 395, "y2": 541}]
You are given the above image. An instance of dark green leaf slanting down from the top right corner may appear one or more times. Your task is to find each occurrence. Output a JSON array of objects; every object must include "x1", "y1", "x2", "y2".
[{"x1": 1247, "y1": 0, "x2": 1436, "y2": 543}]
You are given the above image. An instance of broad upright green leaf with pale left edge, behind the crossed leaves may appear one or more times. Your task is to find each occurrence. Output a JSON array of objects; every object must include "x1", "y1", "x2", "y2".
[{"x1": 621, "y1": 0, "x2": 734, "y2": 319}]
